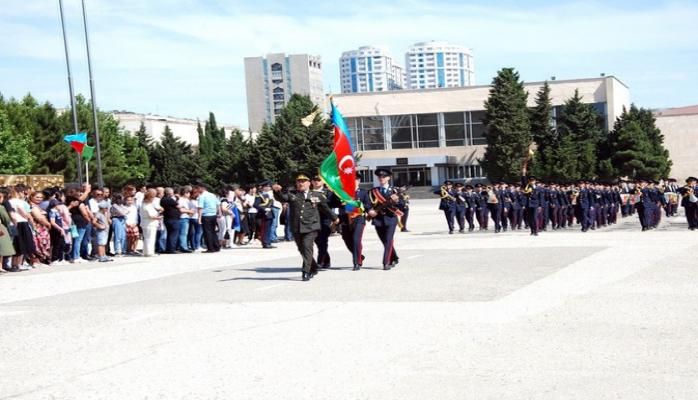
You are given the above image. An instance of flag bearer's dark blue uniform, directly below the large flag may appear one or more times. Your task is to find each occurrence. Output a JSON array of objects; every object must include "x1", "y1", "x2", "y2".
[{"x1": 328, "y1": 174, "x2": 371, "y2": 271}]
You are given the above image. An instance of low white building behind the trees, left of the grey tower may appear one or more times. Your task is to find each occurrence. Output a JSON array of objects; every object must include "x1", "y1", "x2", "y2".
[{"x1": 111, "y1": 111, "x2": 250, "y2": 146}]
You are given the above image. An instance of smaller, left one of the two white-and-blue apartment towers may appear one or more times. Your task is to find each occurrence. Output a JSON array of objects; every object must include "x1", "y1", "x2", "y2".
[{"x1": 339, "y1": 46, "x2": 405, "y2": 93}]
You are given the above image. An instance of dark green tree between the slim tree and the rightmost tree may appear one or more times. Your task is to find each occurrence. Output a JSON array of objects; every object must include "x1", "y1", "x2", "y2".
[{"x1": 557, "y1": 90, "x2": 603, "y2": 179}]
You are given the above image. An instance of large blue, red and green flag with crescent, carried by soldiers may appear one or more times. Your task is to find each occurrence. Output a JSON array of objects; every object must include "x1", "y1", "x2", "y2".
[{"x1": 320, "y1": 102, "x2": 363, "y2": 214}]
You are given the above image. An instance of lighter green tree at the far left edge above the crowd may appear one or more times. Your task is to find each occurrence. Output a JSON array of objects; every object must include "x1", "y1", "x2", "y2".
[{"x1": 0, "y1": 108, "x2": 34, "y2": 174}]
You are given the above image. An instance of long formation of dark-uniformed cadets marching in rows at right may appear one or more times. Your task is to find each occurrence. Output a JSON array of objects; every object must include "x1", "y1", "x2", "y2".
[{"x1": 434, "y1": 176, "x2": 698, "y2": 236}]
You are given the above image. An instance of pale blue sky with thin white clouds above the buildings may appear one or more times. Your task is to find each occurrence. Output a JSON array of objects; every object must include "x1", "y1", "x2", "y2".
[{"x1": 0, "y1": 0, "x2": 698, "y2": 128}]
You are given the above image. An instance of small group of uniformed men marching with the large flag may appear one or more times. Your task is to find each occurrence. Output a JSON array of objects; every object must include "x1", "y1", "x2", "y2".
[{"x1": 272, "y1": 169, "x2": 409, "y2": 281}]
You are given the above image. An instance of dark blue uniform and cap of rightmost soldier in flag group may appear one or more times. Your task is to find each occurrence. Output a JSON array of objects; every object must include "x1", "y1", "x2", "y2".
[{"x1": 369, "y1": 168, "x2": 404, "y2": 270}]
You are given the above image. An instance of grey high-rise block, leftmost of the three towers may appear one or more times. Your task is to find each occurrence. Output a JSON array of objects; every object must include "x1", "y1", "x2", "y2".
[{"x1": 245, "y1": 53, "x2": 324, "y2": 132}]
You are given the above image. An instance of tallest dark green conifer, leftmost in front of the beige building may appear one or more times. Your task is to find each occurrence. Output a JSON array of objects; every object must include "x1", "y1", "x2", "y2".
[{"x1": 480, "y1": 68, "x2": 532, "y2": 181}]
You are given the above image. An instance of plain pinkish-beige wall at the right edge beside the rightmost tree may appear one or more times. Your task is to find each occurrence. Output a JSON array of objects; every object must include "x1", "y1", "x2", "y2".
[{"x1": 657, "y1": 114, "x2": 698, "y2": 182}]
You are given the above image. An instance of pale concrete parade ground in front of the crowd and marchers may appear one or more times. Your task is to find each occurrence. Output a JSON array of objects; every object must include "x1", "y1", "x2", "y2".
[{"x1": 0, "y1": 200, "x2": 698, "y2": 400}]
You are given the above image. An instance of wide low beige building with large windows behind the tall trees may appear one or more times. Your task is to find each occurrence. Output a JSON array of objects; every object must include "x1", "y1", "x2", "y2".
[{"x1": 334, "y1": 76, "x2": 630, "y2": 186}]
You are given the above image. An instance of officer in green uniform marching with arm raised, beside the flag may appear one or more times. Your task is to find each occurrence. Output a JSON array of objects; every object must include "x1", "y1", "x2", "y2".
[{"x1": 272, "y1": 174, "x2": 339, "y2": 281}]
